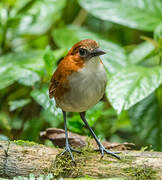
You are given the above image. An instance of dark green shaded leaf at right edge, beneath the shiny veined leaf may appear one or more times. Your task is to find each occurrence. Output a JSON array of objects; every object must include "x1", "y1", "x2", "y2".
[{"x1": 128, "y1": 94, "x2": 162, "y2": 151}]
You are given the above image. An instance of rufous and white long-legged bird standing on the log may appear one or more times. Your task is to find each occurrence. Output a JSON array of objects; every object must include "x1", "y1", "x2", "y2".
[{"x1": 49, "y1": 39, "x2": 120, "y2": 162}]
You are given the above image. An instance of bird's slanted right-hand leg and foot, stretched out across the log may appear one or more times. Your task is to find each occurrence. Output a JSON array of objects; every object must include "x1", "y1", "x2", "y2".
[{"x1": 80, "y1": 112, "x2": 120, "y2": 159}]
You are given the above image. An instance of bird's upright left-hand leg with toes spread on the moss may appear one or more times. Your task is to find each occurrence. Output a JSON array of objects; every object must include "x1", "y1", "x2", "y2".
[{"x1": 60, "y1": 111, "x2": 81, "y2": 161}]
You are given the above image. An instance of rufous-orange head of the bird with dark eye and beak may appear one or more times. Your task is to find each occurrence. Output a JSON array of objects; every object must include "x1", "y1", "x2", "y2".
[{"x1": 68, "y1": 39, "x2": 105, "y2": 60}]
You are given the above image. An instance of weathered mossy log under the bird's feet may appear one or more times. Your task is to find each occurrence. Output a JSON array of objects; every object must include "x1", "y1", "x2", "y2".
[{"x1": 0, "y1": 141, "x2": 162, "y2": 179}]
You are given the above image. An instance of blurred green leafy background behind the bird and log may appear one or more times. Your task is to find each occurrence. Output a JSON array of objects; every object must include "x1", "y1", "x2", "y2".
[{"x1": 0, "y1": 0, "x2": 162, "y2": 151}]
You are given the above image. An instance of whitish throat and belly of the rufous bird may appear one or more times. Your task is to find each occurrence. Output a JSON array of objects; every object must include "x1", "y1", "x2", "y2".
[{"x1": 57, "y1": 57, "x2": 107, "y2": 112}]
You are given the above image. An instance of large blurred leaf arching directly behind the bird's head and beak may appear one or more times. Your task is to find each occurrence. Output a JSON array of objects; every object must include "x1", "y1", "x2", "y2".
[{"x1": 53, "y1": 26, "x2": 128, "y2": 73}]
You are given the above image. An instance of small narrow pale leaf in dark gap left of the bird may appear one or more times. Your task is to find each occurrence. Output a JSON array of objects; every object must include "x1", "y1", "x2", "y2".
[{"x1": 9, "y1": 99, "x2": 31, "y2": 111}]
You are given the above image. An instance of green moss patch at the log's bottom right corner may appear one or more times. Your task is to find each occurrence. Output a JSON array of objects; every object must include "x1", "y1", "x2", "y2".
[{"x1": 123, "y1": 165, "x2": 156, "y2": 180}]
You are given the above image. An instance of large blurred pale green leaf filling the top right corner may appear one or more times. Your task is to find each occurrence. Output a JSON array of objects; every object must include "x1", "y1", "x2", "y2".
[{"x1": 79, "y1": 0, "x2": 162, "y2": 31}]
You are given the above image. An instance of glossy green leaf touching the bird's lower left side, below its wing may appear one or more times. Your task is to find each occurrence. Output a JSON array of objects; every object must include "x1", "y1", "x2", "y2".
[{"x1": 31, "y1": 86, "x2": 62, "y2": 117}]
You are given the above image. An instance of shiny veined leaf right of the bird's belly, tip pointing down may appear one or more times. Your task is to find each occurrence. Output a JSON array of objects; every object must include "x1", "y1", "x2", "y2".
[{"x1": 106, "y1": 66, "x2": 162, "y2": 113}]
